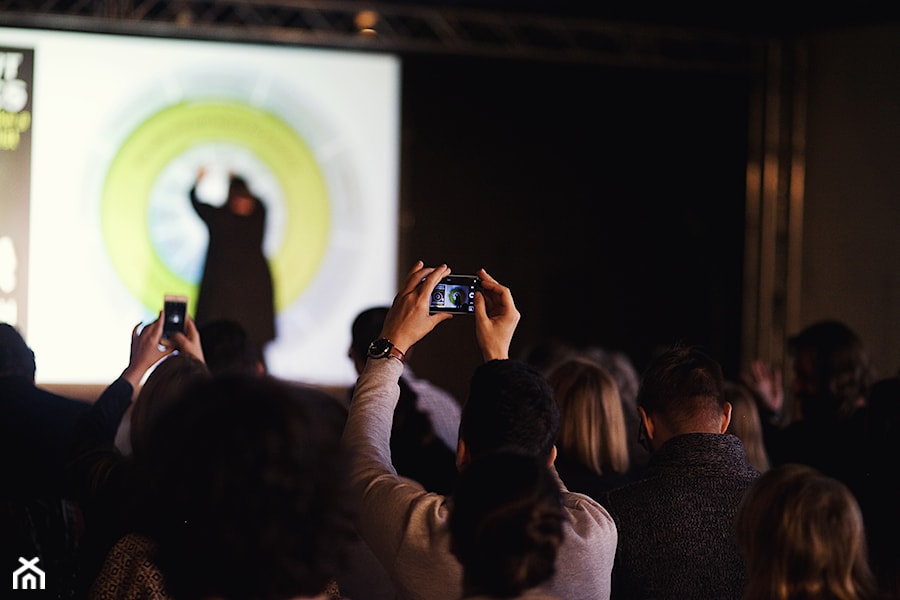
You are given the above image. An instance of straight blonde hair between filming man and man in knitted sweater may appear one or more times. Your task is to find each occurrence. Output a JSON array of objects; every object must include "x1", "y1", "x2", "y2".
[{"x1": 547, "y1": 358, "x2": 630, "y2": 475}]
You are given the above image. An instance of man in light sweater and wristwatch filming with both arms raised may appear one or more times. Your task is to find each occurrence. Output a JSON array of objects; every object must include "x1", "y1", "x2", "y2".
[{"x1": 343, "y1": 262, "x2": 618, "y2": 600}]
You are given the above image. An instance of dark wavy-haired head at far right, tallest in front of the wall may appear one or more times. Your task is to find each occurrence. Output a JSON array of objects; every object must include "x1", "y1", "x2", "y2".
[{"x1": 788, "y1": 320, "x2": 872, "y2": 419}]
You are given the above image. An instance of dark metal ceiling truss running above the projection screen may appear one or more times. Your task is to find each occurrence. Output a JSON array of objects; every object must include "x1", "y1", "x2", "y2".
[{"x1": 0, "y1": 0, "x2": 754, "y2": 71}]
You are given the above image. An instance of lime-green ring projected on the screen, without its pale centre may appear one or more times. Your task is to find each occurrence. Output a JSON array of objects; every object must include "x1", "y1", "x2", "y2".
[{"x1": 100, "y1": 101, "x2": 331, "y2": 312}]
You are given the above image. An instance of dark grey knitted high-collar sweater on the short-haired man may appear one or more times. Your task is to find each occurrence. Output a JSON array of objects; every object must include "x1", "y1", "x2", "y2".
[{"x1": 604, "y1": 433, "x2": 759, "y2": 600}]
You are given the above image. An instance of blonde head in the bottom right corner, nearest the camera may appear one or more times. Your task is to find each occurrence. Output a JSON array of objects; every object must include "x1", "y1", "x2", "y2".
[{"x1": 735, "y1": 463, "x2": 875, "y2": 600}]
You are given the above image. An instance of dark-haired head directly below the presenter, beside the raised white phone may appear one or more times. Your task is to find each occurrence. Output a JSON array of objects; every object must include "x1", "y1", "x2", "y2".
[{"x1": 198, "y1": 319, "x2": 266, "y2": 375}]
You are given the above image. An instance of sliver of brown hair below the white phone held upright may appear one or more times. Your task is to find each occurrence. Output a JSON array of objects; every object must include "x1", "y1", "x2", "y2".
[{"x1": 121, "y1": 352, "x2": 211, "y2": 455}]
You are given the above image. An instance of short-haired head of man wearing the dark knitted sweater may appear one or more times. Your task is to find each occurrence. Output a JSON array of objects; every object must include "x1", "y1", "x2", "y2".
[{"x1": 638, "y1": 346, "x2": 725, "y2": 433}]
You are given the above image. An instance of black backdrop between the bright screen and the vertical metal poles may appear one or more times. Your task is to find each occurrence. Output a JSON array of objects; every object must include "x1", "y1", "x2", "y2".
[{"x1": 398, "y1": 51, "x2": 751, "y2": 397}]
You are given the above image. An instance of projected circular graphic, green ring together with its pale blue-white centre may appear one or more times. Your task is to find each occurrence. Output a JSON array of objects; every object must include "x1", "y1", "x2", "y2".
[{"x1": 101, "y1": 101, "x2": 331, "y2": 312}]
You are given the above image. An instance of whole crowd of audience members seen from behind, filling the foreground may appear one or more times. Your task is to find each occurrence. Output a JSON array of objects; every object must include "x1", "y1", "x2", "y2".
[{"x1": 8, "y1": 264, "x2": 900, "y2": 600}]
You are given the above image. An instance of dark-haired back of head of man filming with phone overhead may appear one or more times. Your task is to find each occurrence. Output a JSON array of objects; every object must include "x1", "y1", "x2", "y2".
[{"x1": 459, "y1": 359, "x2": 559, "y2": 459}]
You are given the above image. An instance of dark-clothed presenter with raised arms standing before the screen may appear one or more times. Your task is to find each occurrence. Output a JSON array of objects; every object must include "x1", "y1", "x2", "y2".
[{"x1": 190, "y1": 168, "x2": 275, "y2": 356}]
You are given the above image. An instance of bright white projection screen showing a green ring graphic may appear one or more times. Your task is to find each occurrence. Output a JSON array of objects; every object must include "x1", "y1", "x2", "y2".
[{"x1": 0, "y1": 28, "x2": 400, "y2": 385}]
